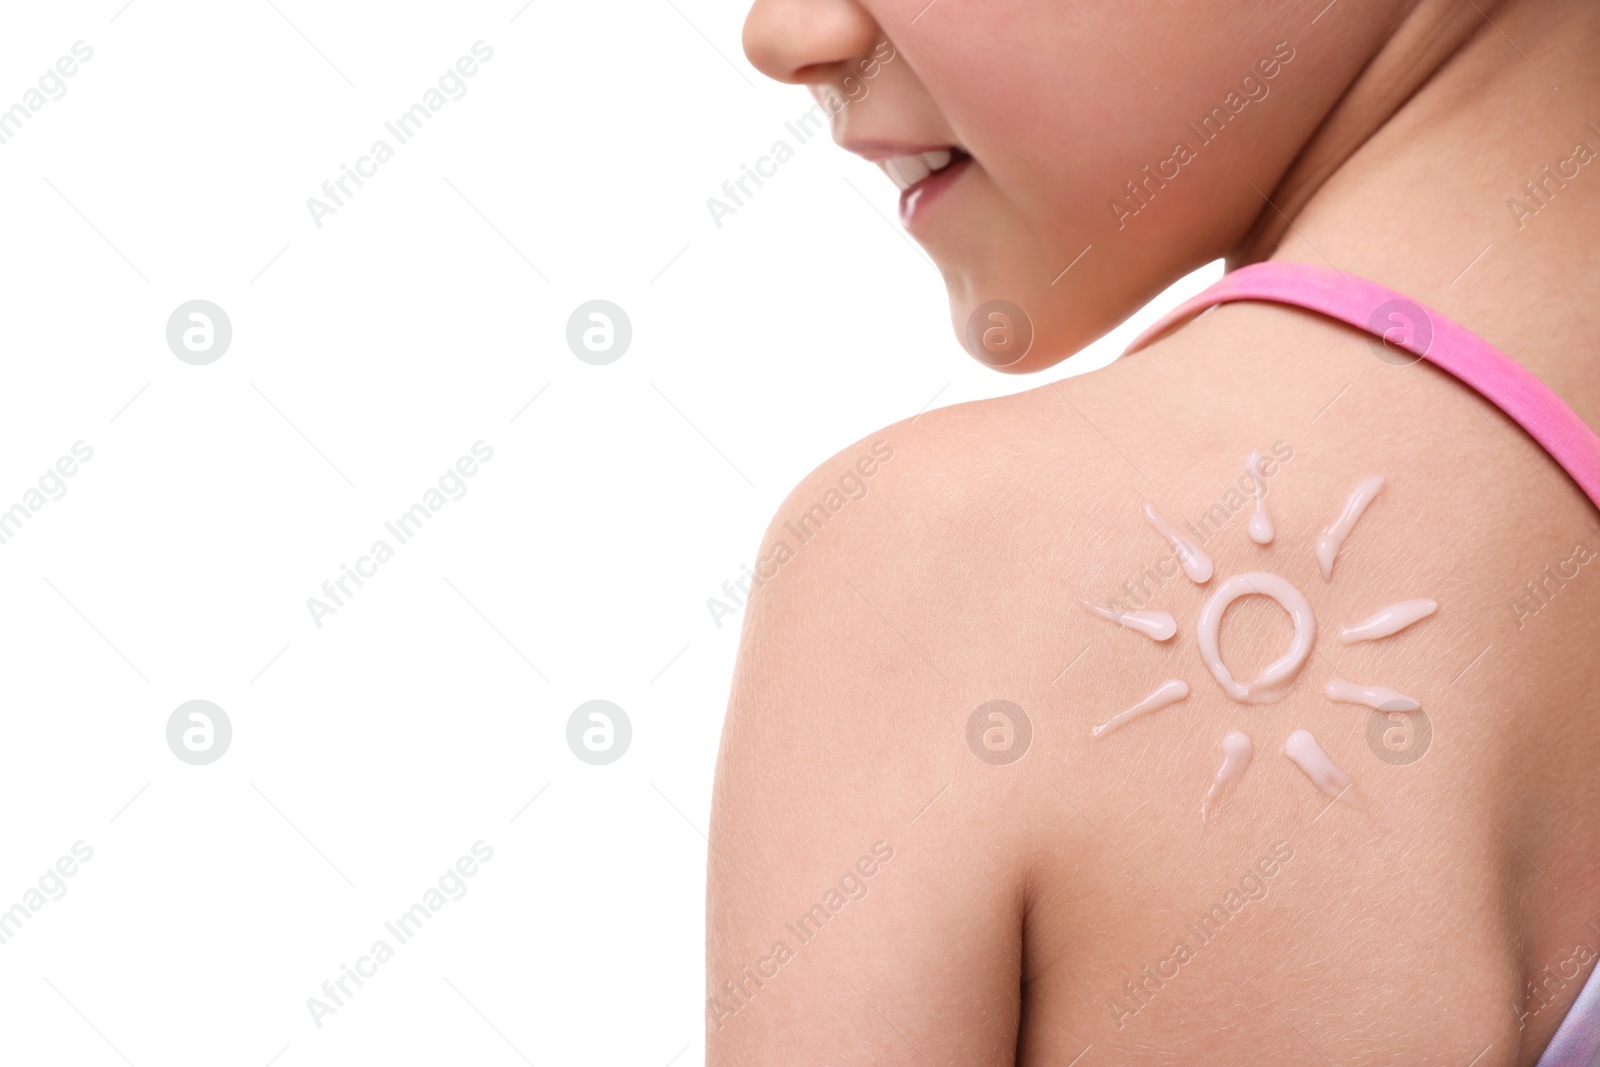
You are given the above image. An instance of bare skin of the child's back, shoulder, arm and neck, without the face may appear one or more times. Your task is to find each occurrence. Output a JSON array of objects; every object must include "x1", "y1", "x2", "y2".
[{"x1": 707, "y1": 3, "x2": 1600, "y2": 1067}]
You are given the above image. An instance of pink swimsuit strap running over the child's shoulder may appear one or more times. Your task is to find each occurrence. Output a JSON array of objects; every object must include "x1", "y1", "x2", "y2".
[{"x1": 1125, "y1": 261, "x2": 1600, "y2": 507}]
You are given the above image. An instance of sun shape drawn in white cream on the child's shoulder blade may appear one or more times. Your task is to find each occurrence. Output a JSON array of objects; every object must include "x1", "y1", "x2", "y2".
[{"x1": 1083, "y1": 453, "x2": 1438, "y2": 819}]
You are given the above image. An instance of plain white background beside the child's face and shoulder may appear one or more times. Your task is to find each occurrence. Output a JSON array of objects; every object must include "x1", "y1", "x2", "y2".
[{"x1": 0, "y1": 0, "x2": 1216, "y2": 1067}]
